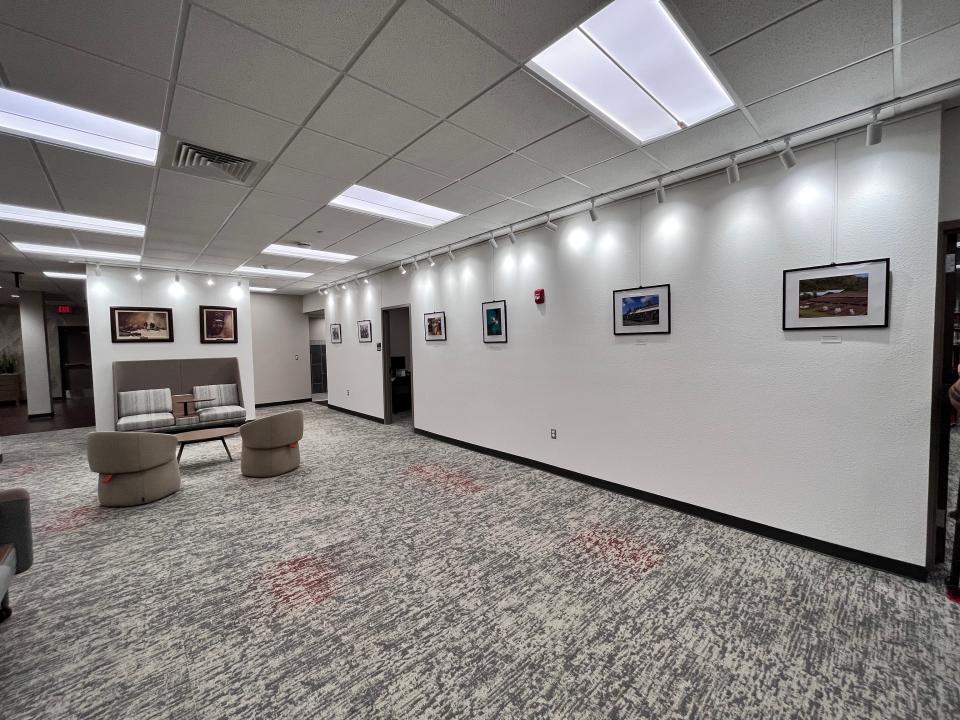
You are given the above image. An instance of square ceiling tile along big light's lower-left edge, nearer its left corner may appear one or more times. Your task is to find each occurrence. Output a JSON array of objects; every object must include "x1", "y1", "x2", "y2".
[{"x1": 451, "y1": 70, "x2": 584, "y2": 150}]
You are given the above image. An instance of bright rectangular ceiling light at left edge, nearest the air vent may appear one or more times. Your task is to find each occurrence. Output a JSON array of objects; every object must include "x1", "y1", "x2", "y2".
[{"x1": 0, "y1": 88, "x2": 160, "y2": 165}]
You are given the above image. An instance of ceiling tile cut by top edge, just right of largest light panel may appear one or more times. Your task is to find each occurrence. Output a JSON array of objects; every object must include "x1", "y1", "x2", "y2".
[{"x1": 664, "y1": 0, "x2": 812, "y2": 53}]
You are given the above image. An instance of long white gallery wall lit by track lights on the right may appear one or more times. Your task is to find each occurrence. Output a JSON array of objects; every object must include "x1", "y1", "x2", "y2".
[{"x1": 312, "y1": 113, "x2": 940, "y2": 565}]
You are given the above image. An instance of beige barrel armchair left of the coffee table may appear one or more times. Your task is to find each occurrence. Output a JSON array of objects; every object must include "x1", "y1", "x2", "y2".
[{"x1": 87, "y1": 432, "x2": 180, "y2": 507}]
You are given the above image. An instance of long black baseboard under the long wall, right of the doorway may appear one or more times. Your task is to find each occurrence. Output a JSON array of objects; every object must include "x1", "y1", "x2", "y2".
[{"x1": 416, "y1": 428, "x2": 927, "y2": 582}]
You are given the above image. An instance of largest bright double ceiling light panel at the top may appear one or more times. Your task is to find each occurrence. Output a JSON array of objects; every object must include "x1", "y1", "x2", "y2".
[{"x1": 528, "y1": 0, "x2": 733, "y2": 143}]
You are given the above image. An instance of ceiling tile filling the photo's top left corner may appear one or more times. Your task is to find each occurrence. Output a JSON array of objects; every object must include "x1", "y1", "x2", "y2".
[{"x1": 0, "y1": 0, "x2": 181, "y2": 78}]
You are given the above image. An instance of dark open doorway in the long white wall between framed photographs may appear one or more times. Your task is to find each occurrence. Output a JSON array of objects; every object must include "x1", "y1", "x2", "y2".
[{"x1": 381, "y1": 305, "x2": 413, "y2": 429}]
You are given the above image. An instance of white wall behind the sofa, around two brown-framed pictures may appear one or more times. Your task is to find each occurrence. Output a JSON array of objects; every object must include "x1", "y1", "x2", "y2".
[{"x1": 87, "y1": 266, "x2": 256, "y2": 430}]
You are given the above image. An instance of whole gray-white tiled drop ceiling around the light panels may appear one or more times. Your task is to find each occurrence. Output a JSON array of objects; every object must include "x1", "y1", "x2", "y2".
[{"x1": 0, "y1": 0, "x2": 960, "y2": 296}]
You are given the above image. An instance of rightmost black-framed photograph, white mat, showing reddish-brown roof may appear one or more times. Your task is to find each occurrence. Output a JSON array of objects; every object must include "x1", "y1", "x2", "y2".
[{"x1": 783, "y1": 258, "x2": 890, "y2": 330}]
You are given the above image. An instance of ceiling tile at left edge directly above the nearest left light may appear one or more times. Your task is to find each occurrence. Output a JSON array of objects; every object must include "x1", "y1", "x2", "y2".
[{"x1": 0, "y1": 25, "x2": 167, "y2": 129}]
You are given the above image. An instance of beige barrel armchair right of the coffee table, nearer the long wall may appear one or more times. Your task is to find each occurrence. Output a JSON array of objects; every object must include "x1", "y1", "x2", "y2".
[{"x1": 240, "y1": 410, "x2": 303, "y2": 477}]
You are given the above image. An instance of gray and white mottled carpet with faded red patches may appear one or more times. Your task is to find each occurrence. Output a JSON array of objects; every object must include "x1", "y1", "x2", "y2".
[{"x1": 0, "y1": 405, "x2": 960, "y2": 720}]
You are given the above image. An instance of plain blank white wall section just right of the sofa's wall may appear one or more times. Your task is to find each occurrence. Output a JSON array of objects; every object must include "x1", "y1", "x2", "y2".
[{"x1": 250, "y1": 293, "x2": 310, "y2": 404}]
